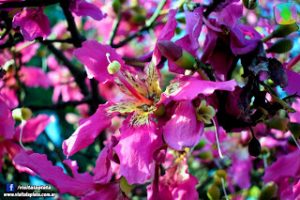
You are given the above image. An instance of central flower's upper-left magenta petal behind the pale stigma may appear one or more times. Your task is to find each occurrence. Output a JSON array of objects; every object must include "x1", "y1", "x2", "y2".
[{"x1": 74, "y1": 40, "x2": 125, "y2": 83}]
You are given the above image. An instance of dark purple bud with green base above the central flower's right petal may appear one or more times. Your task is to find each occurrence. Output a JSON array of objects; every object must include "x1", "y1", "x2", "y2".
[{"x1": 157, "y1": 41, "x2": 196, "y2": 69}]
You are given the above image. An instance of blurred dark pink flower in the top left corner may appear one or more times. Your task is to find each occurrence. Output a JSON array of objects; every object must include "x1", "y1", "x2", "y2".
[{"x1": 13, "y1": 8, "x2": 51, "y2": 41}]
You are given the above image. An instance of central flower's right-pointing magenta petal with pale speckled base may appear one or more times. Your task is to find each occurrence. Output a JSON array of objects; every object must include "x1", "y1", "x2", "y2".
[{"x1": 165, "y1": 76, "x2": 237, "y2": 101}]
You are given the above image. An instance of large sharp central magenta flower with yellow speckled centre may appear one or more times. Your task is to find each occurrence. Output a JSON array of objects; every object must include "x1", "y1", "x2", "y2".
[{"x1": 63, "y1": 38, "x2": 236, "y2": 184}]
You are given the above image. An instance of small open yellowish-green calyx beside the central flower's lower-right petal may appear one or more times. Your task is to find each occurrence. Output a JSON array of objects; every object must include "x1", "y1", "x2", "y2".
[{"x1": 196, "y1": 100, "x2": 216, "y2": 124}]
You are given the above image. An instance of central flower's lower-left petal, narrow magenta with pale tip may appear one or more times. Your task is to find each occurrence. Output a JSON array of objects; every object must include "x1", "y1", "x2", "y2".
[{"x1": 63, "y1": 104, "x2": 111, "y2": 156}]
